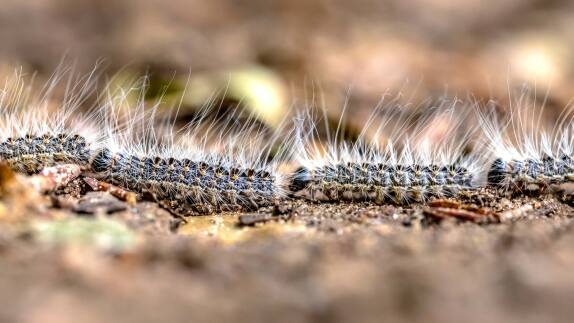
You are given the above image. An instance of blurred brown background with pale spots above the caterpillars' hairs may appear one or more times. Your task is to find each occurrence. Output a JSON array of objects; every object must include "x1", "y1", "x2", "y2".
[{"x1": 0, "y1": 0, "x2": 574, "y2": 130}]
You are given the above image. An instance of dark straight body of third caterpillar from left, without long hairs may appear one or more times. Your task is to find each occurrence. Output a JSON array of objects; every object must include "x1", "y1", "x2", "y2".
[{"x1": 290, "y1": 163, "x2": 473, "y2": 204}]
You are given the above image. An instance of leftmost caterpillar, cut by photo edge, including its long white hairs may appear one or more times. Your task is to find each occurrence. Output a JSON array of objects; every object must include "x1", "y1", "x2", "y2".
[{"x1": 0, "y1": 66, "x2": 102, "y2": 174}]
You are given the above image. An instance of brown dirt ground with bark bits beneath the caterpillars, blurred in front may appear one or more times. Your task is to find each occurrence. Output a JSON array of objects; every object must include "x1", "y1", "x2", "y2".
[{"x1": 0, "y1": 172, "x2": 574, "y2": 322}]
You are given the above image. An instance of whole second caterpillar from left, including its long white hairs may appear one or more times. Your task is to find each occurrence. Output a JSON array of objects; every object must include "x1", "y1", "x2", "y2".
[{"x1": 90, "y1": 81, "x2": 292, "y2": 216}]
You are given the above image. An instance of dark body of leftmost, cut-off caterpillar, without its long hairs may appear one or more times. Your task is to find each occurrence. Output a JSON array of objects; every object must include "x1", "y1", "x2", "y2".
[{"x1": 0, "y1": 134, "x2": 90, "y2": 174}]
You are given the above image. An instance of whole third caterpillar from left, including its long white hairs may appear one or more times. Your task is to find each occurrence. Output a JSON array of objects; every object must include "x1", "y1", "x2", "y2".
[{"x1": 290, "y1": 100, "x2": 480, "y2": 208}]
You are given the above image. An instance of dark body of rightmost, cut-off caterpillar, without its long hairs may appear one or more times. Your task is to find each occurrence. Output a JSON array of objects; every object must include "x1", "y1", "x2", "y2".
[{"x1": 488, "y1": 154, "x2": 574, "y2": 191}]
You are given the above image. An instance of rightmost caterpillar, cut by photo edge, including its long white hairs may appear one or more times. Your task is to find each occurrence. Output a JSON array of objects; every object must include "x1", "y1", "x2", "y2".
[{"x1": 477, "y1": 88, "x2": 574, "y2": 194}]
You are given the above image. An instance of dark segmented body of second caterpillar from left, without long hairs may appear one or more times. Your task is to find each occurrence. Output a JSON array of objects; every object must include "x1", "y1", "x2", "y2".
[{"x1": 91, "y1": 149, "x2": 277, "y2": 214}]
